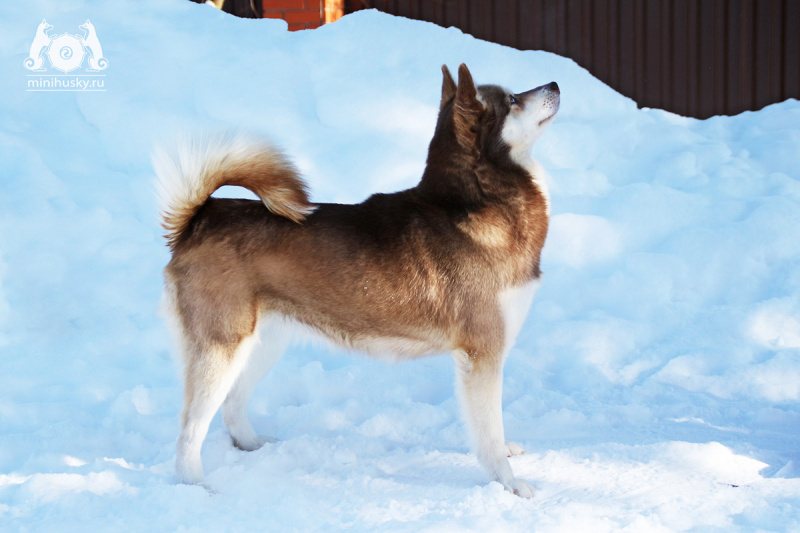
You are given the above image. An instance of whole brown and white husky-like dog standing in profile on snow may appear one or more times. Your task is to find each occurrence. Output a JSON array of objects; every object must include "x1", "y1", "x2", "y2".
[{"x1": 153, "y1": 64, "x2": 560, "y2": 498}]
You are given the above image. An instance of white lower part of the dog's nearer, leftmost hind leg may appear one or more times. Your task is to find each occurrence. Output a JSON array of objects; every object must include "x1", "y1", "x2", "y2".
[{"x1": 175, "y1": 335, "x2": 255, "y2": 483}]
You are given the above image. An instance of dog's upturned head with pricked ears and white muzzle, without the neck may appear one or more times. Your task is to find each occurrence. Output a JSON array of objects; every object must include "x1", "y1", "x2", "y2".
[{"x1": 437, "y1": 64, "x2": 561, "y2": 168}]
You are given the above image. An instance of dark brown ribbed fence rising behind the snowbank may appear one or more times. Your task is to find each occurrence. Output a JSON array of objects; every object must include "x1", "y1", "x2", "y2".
[{"x1": 345, "y1": 0, "x2": 800, "y2": 118}]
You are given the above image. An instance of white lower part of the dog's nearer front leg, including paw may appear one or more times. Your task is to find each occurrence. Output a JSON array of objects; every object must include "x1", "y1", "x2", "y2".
[{"x1": 454, "y1": 351, "x2": 534, "y2": 498}]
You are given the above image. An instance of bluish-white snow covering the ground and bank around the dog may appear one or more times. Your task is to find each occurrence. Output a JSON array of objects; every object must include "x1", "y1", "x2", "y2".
[{"x1": 0, "y1": 0, "x2": 800, "y2": 532}]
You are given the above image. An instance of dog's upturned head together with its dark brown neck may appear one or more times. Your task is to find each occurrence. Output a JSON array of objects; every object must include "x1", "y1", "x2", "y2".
[{"x1": 418, "y1": 64, "x2": 560, "y2": 204}]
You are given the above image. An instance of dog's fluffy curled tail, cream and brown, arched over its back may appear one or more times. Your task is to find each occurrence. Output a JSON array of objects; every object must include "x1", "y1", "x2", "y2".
[{"x1": 153, "y1": 135, "x2": 314, "y2": 249}]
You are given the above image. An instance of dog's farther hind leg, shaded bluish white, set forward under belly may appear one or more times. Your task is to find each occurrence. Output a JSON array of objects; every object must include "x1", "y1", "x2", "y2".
[{"x1": 222, "y1": 319, "x2": 289, "y2": 451}]
